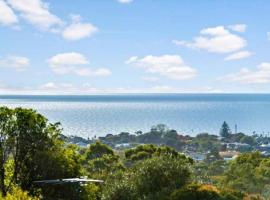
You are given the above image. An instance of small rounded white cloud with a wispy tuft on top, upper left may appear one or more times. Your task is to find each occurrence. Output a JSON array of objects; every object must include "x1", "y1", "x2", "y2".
[{"x1": 62, "y1": 15, "x2": 98, "y2": 41}]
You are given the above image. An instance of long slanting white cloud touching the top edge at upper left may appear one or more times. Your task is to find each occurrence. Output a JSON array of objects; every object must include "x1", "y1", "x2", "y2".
[{"x1": 7, "y1": 0, "x2": 63, "y2": 31}]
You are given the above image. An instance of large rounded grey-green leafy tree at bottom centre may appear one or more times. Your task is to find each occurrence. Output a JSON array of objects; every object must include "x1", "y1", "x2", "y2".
[{"x1": 102, "y1": 156, "x2": 191, "y2": 200}]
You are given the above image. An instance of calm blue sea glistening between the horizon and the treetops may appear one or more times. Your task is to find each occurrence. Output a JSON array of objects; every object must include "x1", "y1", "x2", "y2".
[{"x1": 0, "y1": 94, "x2": 270, "y2": 137}]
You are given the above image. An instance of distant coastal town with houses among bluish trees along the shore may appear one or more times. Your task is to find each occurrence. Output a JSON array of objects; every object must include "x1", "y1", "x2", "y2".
[{"x1": 62, "y1": 122, "x2": 270, "y2": 161}]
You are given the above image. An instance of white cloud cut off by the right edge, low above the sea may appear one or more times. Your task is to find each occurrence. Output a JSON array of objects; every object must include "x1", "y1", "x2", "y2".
[{"x1": 220, "y1": 63, "x2": 270, "y2": 84}]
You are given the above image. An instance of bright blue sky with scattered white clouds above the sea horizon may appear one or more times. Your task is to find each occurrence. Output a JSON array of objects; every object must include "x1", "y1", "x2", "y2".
[{"x1": 0, "y1": 0, "x2": 270, "y2": 94}]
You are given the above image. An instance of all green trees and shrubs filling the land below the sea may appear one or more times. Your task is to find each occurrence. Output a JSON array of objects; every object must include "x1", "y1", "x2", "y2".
[{"x1": 0, "y1": 107, "x2": 270, "y2": 200}]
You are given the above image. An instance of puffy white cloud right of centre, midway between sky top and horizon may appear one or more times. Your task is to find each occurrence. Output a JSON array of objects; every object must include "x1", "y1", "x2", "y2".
[{"x1": 126, "y1": 55, "x2": 197, "y2": 80}]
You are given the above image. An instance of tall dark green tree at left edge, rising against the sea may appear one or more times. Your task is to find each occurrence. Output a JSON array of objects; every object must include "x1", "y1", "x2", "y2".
[{"x1": 0, "y1": 107, "x2": 60, "y2": 196}]
